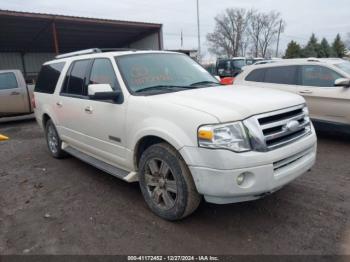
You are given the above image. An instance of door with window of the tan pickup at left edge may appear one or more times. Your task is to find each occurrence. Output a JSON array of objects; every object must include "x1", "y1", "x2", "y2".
[{"x1": 0, "y1": 72, "x2": 29, "y2": 115}]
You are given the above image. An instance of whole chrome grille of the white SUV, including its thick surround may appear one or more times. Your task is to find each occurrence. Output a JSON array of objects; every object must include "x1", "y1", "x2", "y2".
[{"x1": 244, "y1": 105, "x2": 311, "y2": 151}]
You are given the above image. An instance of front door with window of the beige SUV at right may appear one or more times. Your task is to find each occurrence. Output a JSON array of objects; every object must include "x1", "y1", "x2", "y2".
[{"x1": 298, "y1": 65, "x2": 350, "y2": 124}]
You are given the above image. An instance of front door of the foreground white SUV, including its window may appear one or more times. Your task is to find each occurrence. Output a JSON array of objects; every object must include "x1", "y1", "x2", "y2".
[{"x1": 81, "y1": 58, "x2": 127, "y2": 167}]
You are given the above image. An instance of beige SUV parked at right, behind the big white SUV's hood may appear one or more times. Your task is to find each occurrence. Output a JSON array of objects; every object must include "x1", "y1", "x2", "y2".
[{"x1": 235, "y1": 58, "x2": 350, "y2": 131}]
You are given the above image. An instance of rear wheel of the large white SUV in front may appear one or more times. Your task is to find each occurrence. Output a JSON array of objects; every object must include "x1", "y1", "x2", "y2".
[{"x1": 45, "y1": 119, "x2": 67, "y2": 158}]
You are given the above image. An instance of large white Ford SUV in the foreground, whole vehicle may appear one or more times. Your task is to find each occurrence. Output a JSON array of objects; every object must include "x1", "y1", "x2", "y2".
[{"x1": 35, "y1": 49, "x2": 316, "y2": 220}]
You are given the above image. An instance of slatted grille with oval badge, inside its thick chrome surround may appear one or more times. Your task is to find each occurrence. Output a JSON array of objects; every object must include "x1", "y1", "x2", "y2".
[{"x1": 257, "y1": 105, "x2": 311, "y2": 150}]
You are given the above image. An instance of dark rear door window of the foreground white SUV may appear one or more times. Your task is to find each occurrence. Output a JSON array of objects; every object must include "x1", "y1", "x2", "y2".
[{"x1": 62, "y1": 60, "x2": 91, "y2": 95}]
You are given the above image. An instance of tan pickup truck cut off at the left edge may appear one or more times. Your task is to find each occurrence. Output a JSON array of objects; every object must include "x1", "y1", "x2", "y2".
[{"x1": 0, "y1": 70, "x2": 34, "y2": 117}]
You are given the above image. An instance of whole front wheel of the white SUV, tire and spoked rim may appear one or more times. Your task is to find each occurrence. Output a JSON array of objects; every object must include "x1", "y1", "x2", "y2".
[{"x1": 139, "y1": 143, "x2": 201, "y2": 221}]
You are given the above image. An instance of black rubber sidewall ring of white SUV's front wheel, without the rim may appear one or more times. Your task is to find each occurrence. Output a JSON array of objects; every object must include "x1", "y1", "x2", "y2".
[{"x1": 139, "y1": 144, "x2": 188, "y2": 221}]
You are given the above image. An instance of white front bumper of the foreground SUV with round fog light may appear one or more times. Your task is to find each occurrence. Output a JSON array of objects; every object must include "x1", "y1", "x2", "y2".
[{"x1": 180, "y1": 126, "x2": 317, "y2": 204}]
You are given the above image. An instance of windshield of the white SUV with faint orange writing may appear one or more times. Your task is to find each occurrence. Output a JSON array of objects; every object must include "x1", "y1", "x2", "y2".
[{"x1": 115, "y1": 53, "x2": 220, "y2": 93}]
